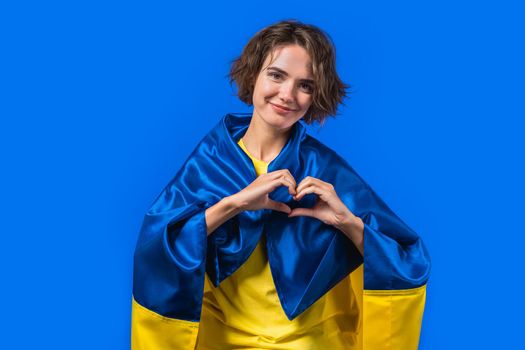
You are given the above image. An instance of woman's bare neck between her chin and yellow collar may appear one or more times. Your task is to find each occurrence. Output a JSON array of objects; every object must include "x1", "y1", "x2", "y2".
[{"x1": 242, "y1": 112, "x2": 292, "y2": 163}]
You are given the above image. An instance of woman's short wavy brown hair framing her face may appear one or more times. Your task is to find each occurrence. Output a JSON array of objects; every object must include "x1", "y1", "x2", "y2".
[{"x1": 229, "y1": 20, "x2": 351, "y2": 125}]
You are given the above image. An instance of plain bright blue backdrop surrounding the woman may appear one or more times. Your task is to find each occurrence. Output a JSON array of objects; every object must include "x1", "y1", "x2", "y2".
[{"x1": 0, "y1": 0, "x2": 525, "y2": 350}]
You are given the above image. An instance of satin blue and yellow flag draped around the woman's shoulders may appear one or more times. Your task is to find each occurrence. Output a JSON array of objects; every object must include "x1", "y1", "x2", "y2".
[{"x1": 132, "y1": 114, "x2": 430, "y2": 350}]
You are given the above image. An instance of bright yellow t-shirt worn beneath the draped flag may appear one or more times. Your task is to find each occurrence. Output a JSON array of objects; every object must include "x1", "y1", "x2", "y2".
[{"x1": 196, "y1": 139, "x2": 363, "y2": 350}]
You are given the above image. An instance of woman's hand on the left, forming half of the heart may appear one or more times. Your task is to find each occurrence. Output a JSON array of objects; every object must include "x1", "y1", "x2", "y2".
[{"x1": 231, "y1": 169, "x2": 297, "y2": 214}]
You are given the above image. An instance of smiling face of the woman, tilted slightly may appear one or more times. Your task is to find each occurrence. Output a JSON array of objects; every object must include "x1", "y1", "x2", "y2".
[{"x1": 253, "y1": 44, "x2": 314, "y2": 130}]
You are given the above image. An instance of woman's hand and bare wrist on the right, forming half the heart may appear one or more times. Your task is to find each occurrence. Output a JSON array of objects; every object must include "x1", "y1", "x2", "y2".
[{"x1": 288, "y1": 176, "x2": 364, "y2": 254}]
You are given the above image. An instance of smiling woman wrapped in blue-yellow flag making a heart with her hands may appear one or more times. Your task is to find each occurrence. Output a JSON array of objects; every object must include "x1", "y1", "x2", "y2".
[{"x1": 132, "y1": 21, "x2": 430, "y2": 349}]
